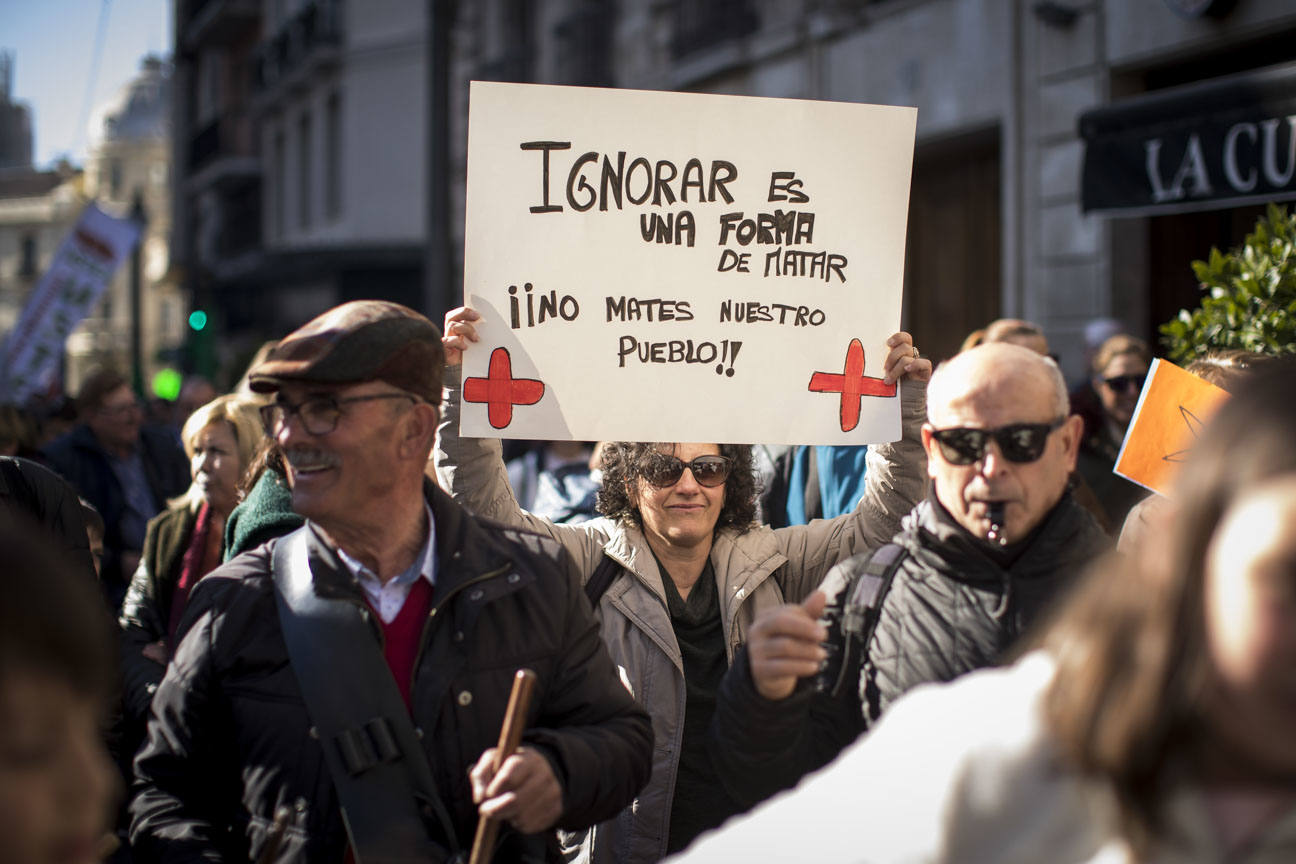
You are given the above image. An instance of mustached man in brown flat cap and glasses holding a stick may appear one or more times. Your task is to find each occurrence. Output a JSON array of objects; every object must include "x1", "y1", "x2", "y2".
[{"x1": 131, "y1": 301, "x2": 652, "y2": 864}]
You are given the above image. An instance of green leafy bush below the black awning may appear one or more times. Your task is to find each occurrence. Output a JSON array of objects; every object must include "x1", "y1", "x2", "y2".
[{"x1": 1161, "y1": 205, "x2": 1296, "y2": 364}]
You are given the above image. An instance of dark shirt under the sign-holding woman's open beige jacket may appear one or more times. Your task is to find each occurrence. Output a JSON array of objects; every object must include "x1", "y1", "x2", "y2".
[{"x1": 657, "y1": 560, "x2": 743, "y2": 855}]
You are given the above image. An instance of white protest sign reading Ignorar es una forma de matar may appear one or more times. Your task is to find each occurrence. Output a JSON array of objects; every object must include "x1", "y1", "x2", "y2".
[{"x1": 461, "y1": 82, "x2": 916, "y2": 444}]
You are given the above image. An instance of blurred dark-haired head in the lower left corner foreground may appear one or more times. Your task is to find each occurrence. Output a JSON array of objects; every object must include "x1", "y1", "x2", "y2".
[{"x1": 0, "y1": 510, "x2": 121, "y2": 864}]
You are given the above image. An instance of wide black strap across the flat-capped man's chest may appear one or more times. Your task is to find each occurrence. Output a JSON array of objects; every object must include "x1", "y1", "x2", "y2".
[{"x1": 273, "y1": 526, "x2": 457, "y2": 864}]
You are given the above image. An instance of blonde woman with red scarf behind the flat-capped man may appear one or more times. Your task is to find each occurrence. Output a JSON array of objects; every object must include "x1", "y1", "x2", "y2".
[{"x1": 121, "y1": 396, "x2": 264, "y2": 758}]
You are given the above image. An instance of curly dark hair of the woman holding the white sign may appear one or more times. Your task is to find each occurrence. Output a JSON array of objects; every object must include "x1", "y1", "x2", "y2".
[{"x1": 596, "y1": 440, "x2": 759, "y2": 532}]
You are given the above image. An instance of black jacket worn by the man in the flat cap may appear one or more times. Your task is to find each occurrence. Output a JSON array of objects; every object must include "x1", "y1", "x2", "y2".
[{"x1": 131, "y1": 486, "x2": 652, "y2": 863}]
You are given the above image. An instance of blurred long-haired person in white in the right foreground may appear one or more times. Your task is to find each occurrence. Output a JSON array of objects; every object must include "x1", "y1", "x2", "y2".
[{"x1": 682, "y1": 363, "x2": 1296, "y2": 864}]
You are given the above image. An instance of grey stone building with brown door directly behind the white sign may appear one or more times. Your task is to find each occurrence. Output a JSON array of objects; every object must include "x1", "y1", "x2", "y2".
[{"x1": 440, "y1": 0, "x2": 1296, "y2": 378}]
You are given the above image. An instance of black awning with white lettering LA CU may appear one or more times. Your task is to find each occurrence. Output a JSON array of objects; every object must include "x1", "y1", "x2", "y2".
[{"x1": 1080, "y1": 63, "x2": 1296, "y2": 216}]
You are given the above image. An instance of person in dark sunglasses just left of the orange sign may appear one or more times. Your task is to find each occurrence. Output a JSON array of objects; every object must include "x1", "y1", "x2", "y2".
[{"x1": 1080, "y1": 334, "x2": 1152, "y2": 531}]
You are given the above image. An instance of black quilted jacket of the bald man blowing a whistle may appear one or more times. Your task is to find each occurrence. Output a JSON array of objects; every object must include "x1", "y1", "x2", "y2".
[{"x1": 710, "y1": 492, "x2": 1109, "y2": 806}]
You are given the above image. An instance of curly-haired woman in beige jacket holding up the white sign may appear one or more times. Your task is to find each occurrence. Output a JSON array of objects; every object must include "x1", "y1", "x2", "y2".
[{"x1": 435, "y1": 308, "x2": 932, "y2": 861}]
